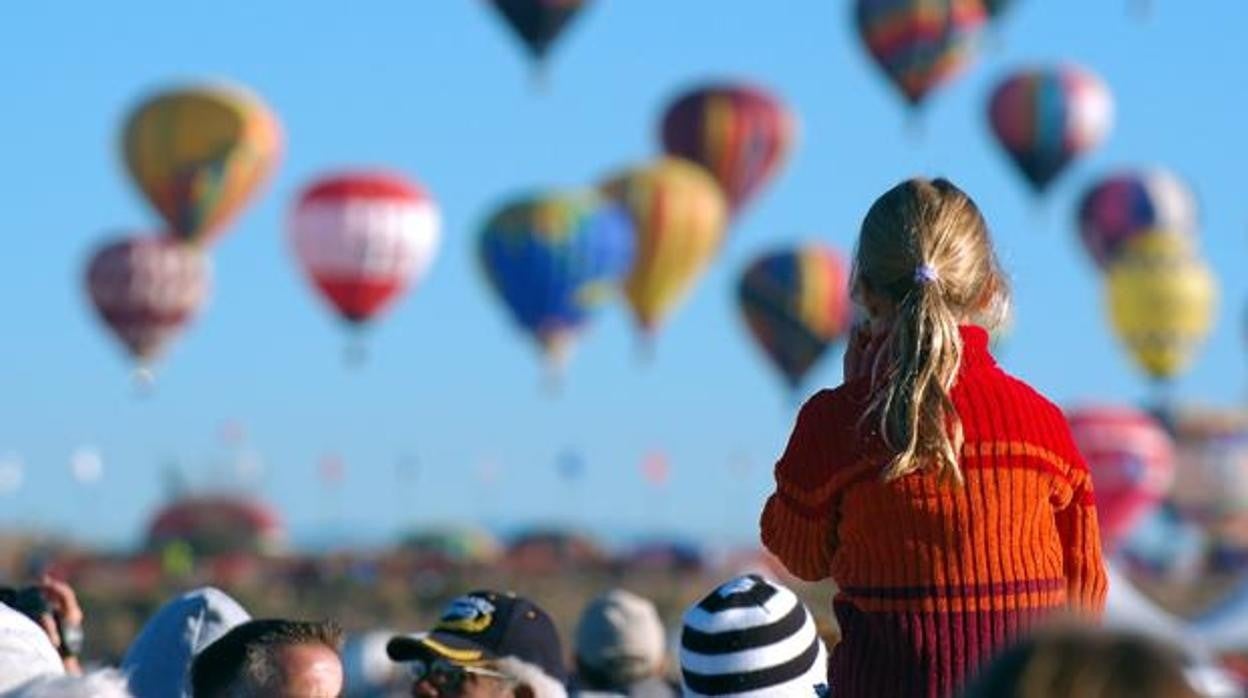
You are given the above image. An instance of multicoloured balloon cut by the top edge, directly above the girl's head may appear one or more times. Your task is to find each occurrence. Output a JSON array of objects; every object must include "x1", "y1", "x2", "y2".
[{"x1": 855, "y1": 0, "x2": 987, "y2": 106}]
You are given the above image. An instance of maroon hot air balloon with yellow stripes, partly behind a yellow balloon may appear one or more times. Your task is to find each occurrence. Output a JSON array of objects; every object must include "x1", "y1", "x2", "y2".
[{"x1": 661, "y1": 85, "x2": 795, "y2": 212}]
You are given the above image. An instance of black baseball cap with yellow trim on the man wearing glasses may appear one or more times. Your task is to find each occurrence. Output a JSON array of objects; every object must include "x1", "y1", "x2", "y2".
[{"x1": 386, "y1": 591, "x2": 567, "y2": 682}]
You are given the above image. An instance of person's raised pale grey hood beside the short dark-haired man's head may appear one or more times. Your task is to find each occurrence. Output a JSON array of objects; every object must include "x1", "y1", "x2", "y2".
[{"x1": 121, "y1": 587, "x2": 251, "y2": 698}]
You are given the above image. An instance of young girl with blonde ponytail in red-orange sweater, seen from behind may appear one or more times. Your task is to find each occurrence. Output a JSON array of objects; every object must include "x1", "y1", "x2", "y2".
[{"x1": 761, "y1": 179, "x2": 1106, "y2": 698}]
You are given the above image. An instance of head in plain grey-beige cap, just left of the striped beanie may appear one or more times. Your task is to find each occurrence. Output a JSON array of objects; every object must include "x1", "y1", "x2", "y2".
[{"x1": 577, "y1": 589, "x2": 666, "y2": 691}]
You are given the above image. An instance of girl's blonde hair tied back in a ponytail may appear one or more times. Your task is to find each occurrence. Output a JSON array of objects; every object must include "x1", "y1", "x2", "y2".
[{"x1": 851, "y1": 179, "x2": 1010, "y2": 482}]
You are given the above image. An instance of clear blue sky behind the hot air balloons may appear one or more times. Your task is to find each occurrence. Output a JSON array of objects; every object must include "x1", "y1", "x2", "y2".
[{"x1": 0, "y1": 0, "x2": 1248, "y2": 544}]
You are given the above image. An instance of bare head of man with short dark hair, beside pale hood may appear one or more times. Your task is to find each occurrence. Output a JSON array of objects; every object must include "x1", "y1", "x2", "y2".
[{"x1": 191, "y1": 619, "x2": 342, "y2": 698}]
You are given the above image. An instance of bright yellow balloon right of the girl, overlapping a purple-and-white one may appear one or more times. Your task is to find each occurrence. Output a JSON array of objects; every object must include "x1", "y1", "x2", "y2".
[{"x1": 1107, "y1": 230, "x2": 1218, "y2": 380}]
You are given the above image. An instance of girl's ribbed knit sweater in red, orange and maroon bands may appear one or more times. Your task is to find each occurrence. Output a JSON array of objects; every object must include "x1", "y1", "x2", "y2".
[{"x1": 761, "y1": 327, "x2": 1106, "y2": 698}]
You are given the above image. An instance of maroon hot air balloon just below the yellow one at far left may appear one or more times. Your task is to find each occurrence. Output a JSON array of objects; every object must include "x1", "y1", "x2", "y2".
[{"x1": 86, "y1": 237, "x2": 208, "y2": 371}]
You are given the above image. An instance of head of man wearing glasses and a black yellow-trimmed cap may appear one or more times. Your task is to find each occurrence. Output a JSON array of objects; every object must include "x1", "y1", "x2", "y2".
[{"x1": 386, "y1": 591, "x2": 567, "y2": 698}]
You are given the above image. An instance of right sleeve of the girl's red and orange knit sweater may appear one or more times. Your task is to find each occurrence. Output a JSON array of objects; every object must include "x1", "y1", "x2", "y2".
[{"x1": 1053, "y1": 412, "x2": 1109, "y2": 617}]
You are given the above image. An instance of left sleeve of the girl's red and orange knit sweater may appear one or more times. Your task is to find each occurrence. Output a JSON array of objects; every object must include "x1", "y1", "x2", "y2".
[{"x1": 760, "y1": 391, "x2": 837, "y2": 582}]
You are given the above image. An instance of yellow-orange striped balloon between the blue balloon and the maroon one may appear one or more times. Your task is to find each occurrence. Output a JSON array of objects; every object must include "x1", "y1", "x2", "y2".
[{"x1": 603, "y1": 157, "x2": 728, "y2": 336}]
